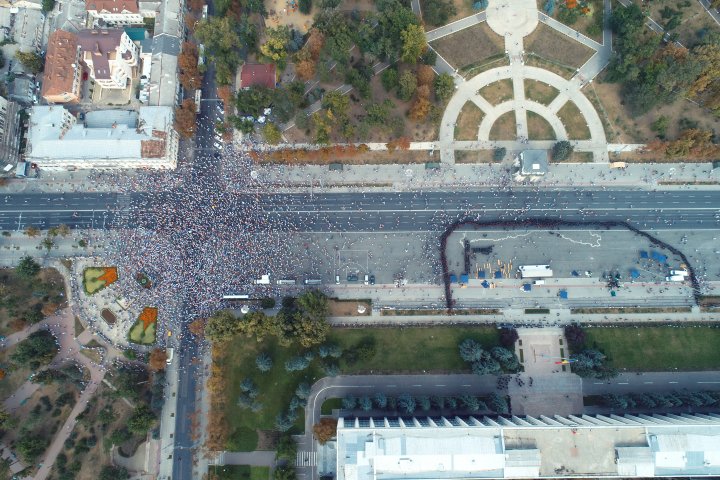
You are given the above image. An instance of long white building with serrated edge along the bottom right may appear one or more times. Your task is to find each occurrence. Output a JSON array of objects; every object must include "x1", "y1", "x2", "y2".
[{"x1": 336, "y1": 414, "x2": 720, "y2": 480}]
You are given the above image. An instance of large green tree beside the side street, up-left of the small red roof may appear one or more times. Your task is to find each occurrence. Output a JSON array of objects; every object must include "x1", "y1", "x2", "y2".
[{"x1": 193, "y1": 16, "x2": 243, "y2": 85}]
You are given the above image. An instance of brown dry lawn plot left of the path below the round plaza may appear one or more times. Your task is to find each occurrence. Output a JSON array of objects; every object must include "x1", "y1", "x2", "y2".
[{"x1": 430, "y1": 22, "x2": 505, "y2": 69}]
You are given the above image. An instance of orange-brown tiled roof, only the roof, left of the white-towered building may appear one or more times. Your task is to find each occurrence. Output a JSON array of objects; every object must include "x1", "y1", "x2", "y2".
[{"x1": 42, "y1": 30, "x2": 78, "y2": 96}]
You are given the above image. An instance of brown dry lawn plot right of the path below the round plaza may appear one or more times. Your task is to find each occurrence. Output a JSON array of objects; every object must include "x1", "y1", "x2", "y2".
[{"x1": 524, "y1": 23, "x2": 595, "y2": 70}]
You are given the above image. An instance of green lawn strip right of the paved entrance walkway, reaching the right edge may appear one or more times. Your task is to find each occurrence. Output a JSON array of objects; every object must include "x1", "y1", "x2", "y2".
[{"x1": 585, "y1": 327, "x2": 720, "y2": 372}]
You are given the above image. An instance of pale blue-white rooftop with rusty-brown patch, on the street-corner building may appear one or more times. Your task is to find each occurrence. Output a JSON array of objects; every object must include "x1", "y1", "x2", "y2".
[{"x1": 27, "y1": 106, "x2": 172, "y2": 160}]
